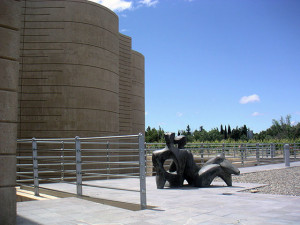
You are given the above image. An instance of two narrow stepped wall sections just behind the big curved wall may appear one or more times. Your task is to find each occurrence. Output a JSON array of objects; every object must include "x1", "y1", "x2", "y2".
[{"x1": 119, "y1": 34, "x2": 145, "y2": 134}]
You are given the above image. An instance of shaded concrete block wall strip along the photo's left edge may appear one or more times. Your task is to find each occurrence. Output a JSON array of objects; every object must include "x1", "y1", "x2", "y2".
[{"x1": 0, "y1": 0, "x2": 20, "y2": 224}]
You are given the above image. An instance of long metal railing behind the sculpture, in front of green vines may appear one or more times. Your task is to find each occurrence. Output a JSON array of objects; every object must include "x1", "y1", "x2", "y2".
[{"x1": 145, "y1": 143, "x2": 300, "y2": 175}]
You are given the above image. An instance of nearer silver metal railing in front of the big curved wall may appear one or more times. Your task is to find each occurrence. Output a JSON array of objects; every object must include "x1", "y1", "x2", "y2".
[{"x1": 17, "y1": 134, "x2": 147, "y2": 209}]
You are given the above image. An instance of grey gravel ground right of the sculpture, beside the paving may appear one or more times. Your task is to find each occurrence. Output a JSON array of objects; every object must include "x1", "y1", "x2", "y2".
[{"x1": 232, "y1": 167, "x2": 300, "y2": 196}]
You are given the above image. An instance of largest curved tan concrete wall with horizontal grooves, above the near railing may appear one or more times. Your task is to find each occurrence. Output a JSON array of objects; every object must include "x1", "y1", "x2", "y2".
[{"x1": 19, "y1": 0, "x2": 119, "y2": 138}]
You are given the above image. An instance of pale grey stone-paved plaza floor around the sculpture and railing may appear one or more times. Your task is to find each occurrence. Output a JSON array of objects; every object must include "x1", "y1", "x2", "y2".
[{"x1": 17, "y1": 162, "x2": 300, "y2": 225}]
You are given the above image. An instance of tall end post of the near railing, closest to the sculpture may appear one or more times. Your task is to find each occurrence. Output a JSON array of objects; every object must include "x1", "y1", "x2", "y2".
[{"x1": 138, "y1": 133, "x2": 147, "y2": 209}]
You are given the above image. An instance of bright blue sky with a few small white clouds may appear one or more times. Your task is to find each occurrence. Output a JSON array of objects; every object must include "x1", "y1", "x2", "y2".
[{"x1": 89, "y1": 0, "x2": 300, "y2": 132}]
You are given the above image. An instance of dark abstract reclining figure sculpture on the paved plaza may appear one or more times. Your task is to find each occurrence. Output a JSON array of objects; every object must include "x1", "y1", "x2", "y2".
[{"x1": 152, "y1": 133, "x2": 240, "y2": 189}]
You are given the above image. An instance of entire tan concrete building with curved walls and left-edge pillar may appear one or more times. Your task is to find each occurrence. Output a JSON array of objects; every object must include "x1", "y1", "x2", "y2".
[{"x1": 0, "y1": 0, "x2": 145, "y2": 224}]
